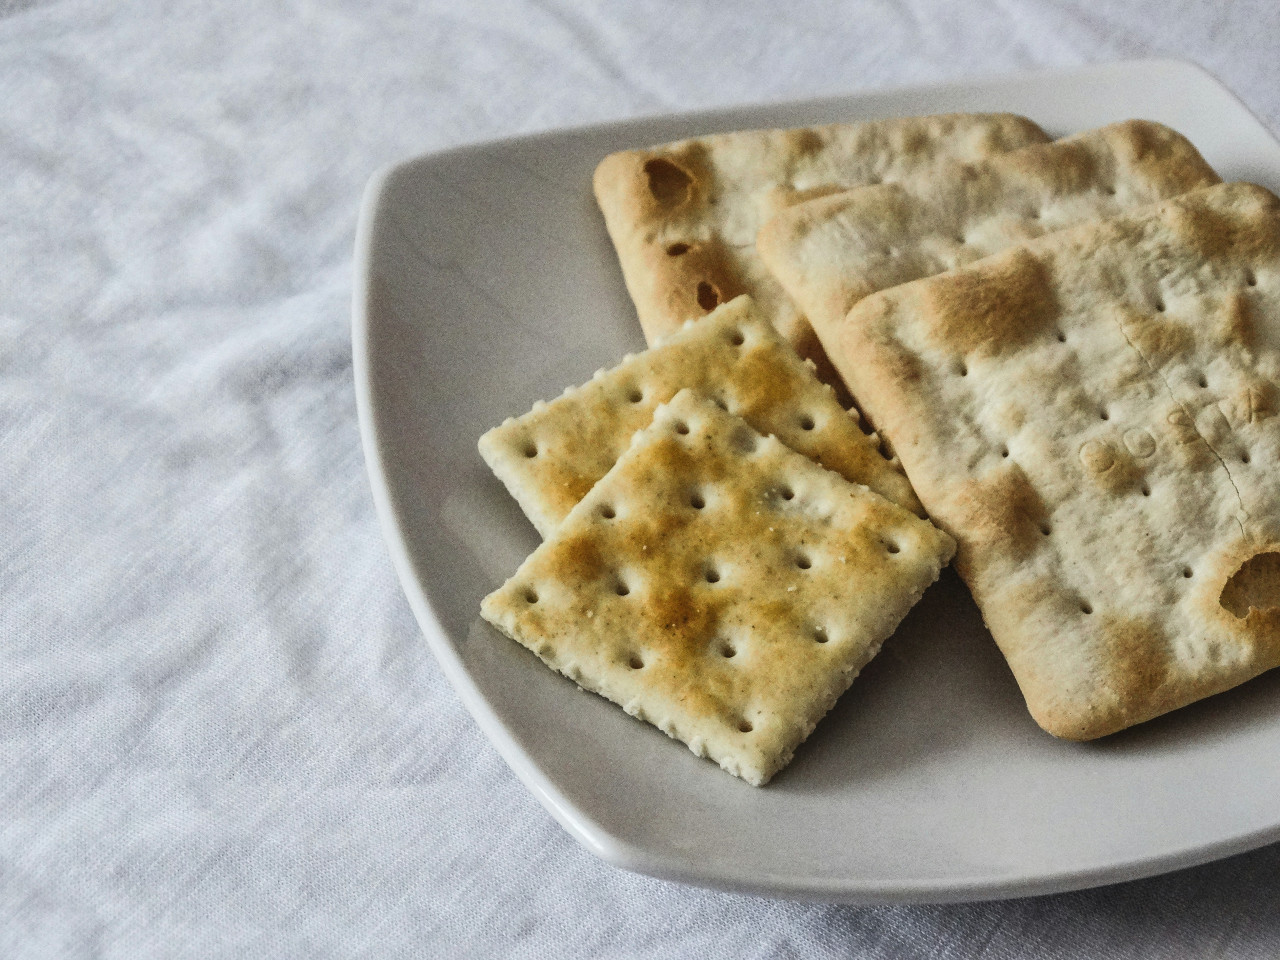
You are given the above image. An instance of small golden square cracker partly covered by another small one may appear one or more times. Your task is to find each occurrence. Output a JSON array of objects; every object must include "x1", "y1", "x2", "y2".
[{"x1": 479, "y1": 297, "x2": 920, "y2": 536}]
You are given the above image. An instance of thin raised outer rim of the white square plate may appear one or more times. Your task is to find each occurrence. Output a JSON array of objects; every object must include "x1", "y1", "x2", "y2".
[{"x1": 351, "y1": 58, "x2": 1280, "y2": 905}]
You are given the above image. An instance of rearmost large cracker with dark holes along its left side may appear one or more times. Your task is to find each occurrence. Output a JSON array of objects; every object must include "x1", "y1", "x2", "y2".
[{"x1": 594, "y1": 114, "x2": 1048, "y2": 381}]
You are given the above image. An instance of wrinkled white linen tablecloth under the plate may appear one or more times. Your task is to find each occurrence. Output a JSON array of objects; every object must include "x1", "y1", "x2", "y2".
[{"x1": 0, "y1": 0, "x2": 1280, "y2": 959}]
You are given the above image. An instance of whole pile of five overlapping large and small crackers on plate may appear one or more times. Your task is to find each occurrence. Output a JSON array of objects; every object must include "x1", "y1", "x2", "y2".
[{"x1": 480, "y1": 114, "x2": 1280, "y2": 785}]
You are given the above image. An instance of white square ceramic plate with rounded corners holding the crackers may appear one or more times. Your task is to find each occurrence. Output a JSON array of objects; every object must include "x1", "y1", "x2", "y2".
[{"x1": 353, "y1": 61, "x2": 1280, "y2": 902}]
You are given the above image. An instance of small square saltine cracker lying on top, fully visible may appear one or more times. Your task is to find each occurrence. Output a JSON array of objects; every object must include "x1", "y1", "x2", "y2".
[{"x1": 480, "y1": 390, "x2": 954, "y2": 786}]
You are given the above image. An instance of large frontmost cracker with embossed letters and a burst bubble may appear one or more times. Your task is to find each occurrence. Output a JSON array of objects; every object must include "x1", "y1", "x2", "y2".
[{"x1": 829, "y1": 183, "x2": 1280, "y2": 740}]
